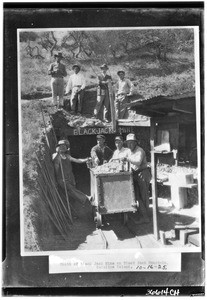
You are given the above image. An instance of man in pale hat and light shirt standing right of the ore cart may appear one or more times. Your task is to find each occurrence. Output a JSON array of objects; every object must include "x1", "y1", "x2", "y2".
[{"x1": 123, "y1": 133, "x2": 151, "y2": 223}]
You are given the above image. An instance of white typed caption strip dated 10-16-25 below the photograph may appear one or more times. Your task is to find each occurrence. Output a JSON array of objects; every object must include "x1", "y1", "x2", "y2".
[{"x1": 49, "y1": 252, "x2": 181, "y2": 274}]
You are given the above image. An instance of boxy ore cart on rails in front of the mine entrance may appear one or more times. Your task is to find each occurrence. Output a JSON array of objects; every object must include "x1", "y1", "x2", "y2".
[{"x1": 90, "y1": 169, "x2": 138, "y2": 227}]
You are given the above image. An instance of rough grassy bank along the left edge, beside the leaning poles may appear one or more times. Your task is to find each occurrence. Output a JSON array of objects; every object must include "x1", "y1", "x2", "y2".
[{"x1": 21, "y1": 101, "x2": 53, "y2": 251}]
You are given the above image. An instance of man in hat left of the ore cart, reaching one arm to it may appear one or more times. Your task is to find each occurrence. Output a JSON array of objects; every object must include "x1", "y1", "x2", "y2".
[{"x1": 52, "y1": 140, "x2": 92, "y2": 204}]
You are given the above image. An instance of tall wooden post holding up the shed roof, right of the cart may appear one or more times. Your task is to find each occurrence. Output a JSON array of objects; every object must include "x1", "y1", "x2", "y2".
[{"x1": 150, "y1": 118, "x2": 159, "y2": 240}]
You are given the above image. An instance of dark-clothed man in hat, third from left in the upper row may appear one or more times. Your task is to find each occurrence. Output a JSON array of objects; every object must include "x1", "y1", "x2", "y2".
[{"x1": 94, "y1": 64, "x2": 112, "y2": 123}]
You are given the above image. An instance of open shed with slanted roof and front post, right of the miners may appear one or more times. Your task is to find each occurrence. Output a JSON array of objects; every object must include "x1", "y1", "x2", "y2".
[{"x1": 128, "y1": 93, "x2": 196, "y2": 240}]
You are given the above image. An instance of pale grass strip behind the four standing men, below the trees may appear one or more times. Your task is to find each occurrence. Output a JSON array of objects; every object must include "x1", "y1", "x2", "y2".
[{"x1": 20, "y1": 41, "x2": 195, "y2": 99}]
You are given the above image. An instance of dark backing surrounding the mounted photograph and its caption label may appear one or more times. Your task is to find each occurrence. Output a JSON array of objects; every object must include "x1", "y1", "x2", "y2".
[{"x1": 2, "y1": 2, "x2": 204, "y2": 296}]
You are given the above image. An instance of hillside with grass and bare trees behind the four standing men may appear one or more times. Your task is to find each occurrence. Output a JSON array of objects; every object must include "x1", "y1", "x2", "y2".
[{"x1": 19, "y1": 29, "x2": 195, "y2": 99}]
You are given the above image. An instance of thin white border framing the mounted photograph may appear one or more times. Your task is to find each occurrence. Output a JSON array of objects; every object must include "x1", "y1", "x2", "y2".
[{"x1": 17, "y1": 26, "x2": 202, "y2": 259}]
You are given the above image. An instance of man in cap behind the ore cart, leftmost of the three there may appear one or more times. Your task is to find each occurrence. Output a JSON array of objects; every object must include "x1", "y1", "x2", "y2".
[{"x1": 91, "y1": 134, "x2": 113, "y2": 166}]
